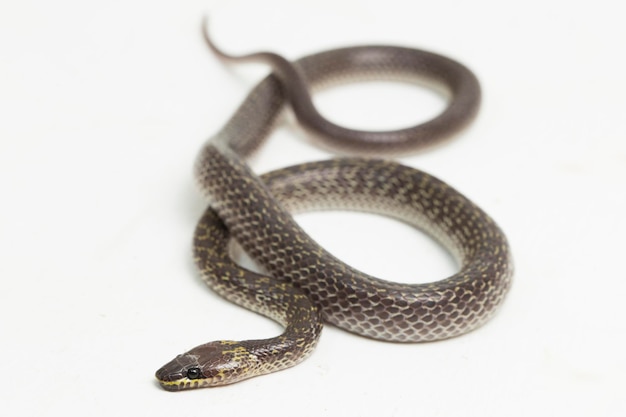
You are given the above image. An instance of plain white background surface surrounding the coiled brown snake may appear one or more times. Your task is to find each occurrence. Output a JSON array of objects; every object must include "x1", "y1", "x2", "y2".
[{"x1": 0, "y1": 0, "x2": 626, "y2": 417}]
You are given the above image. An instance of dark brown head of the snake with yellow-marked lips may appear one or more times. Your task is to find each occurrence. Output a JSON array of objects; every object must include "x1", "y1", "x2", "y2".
[{"x1": 155, "y1": 341, "x2": 257, "y2": 391}]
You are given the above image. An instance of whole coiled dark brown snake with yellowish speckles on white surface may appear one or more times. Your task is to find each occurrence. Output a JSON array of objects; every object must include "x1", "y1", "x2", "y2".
[{"x1": 156, "y1": 21, "x2": 513, "y2": 391}]
